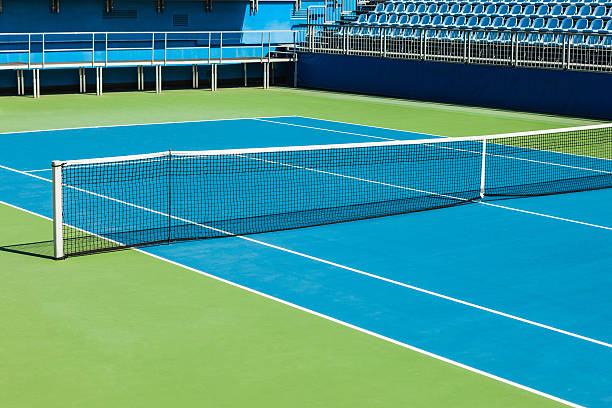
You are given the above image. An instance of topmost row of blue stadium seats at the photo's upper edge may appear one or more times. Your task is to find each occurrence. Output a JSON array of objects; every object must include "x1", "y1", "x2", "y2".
[{"x1": 371, "y1": 3, "x2": 612, "y2": 20}]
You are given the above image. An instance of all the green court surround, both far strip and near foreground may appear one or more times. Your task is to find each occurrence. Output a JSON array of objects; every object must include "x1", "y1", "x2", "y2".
[{"x1": 0, "y1": 89, "x2": 593, "y2": 408}]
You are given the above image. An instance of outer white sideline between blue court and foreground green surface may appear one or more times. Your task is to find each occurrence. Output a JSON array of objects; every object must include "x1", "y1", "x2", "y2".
[{"x1": 0, "y1": 201, "x2": 585, "y2": 408}]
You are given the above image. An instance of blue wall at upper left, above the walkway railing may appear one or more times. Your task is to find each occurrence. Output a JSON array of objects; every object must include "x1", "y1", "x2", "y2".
[{"x1": 0, "y1": 0, "x2": 308, "y2": 33}]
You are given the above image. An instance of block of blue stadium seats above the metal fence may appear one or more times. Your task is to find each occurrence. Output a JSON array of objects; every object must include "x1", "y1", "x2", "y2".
[{"x1": 334, "y1": 0, "x2": 612, "y2": 47}]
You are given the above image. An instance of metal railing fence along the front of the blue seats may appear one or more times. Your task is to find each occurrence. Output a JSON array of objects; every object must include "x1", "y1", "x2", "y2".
[{"x1": 298, "y1": 24, "x2": 612, "y2": 72}]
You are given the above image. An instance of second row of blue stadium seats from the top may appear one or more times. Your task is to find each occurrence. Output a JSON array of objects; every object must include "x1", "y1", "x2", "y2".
[{"x1": 356, "y1": 14, "x2": 612, "y2": 34}]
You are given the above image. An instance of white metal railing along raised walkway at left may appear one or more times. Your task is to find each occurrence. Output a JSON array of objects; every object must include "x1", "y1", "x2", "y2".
[{"x1": 0, "y1": 30, "x2": 298, "y2": 69}]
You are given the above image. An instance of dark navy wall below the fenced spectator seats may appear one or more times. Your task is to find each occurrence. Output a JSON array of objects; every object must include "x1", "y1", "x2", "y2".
[{"x1": 298, "y1": 54, "x2": 612, "y2": 119}]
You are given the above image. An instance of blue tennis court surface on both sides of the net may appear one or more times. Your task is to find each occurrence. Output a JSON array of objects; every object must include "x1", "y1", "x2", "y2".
[{"x1": 0, "y1": 117, "x2": 612, "y2": 407}]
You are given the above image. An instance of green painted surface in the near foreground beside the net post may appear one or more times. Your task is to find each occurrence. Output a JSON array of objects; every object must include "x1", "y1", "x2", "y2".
[{"x1": 0, "y1": 206, "x2": 558, "y2": 408}]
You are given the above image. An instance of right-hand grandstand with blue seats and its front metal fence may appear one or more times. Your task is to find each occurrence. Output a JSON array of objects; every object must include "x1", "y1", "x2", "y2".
[{"x1": 300, "y1": 0, "x2": 612, "y2": 72}]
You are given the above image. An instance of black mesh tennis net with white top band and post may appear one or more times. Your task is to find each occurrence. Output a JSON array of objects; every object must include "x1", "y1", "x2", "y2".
[{"x1": 53, "y1": 125, "x2": 612, "y2": 258}]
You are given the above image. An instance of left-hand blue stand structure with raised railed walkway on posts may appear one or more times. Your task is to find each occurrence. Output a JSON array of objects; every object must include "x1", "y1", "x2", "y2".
[{"x1": 0, "y1": 0, "x2": 330, "y2": 98}]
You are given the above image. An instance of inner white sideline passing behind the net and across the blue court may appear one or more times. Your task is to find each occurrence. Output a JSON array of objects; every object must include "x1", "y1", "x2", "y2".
[{"x1": 0, "y1": 165, "x2": 612, "y2": 348}]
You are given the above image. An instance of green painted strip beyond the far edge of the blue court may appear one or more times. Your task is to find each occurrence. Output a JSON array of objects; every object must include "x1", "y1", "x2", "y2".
[{"x1": 0, "y1": 88, "x2": 596, "y2": 136}]
